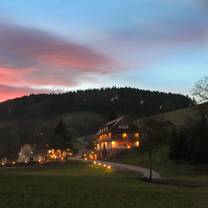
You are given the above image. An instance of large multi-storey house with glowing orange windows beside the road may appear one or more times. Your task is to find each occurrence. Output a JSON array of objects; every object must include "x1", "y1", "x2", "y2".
[{"x1": 95, "y1": 116, "x2": 141, "y2": 158}]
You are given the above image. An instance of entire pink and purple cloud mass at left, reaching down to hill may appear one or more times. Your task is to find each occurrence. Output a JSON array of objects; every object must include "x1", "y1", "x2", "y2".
[{"x1": 0, "y1": 22, "x2": 117, "y2": 101}]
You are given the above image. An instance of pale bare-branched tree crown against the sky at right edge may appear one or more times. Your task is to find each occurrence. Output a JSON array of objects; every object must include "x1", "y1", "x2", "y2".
[{"x1": 193, "y1": 76, "x2": 208, "y2": 102}]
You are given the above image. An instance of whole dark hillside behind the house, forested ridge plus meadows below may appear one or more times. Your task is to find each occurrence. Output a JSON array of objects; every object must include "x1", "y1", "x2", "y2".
[{"x1": 0, "y1": 88, "x2": 193, "y2": 157}]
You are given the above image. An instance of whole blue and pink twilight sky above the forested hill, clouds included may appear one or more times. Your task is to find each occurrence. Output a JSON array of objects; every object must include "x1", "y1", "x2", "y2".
[{"x1": 0, "y1": 0, "x2": 208, "y2": 101}]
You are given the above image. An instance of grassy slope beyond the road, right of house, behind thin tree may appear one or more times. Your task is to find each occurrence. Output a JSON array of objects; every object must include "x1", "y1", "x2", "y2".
[{"x1": 108, "y1": 147, "x2": 208, "y2": 186}]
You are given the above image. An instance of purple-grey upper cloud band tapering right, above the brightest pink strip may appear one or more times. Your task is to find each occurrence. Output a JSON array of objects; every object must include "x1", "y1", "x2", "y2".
[{"x1": 0, "y1": 22, "x2": 113, "y2": 71}]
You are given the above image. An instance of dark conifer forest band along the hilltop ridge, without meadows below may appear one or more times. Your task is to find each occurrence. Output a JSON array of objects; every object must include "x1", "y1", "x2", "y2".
[{"x1": 0, "y1": 87, "x2": 193, "y2": 121}]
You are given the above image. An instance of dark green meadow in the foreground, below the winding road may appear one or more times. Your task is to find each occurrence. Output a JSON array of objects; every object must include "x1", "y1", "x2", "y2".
[{"x1": 0, "y1": 163, "x2": 208, "y2": 208}]
